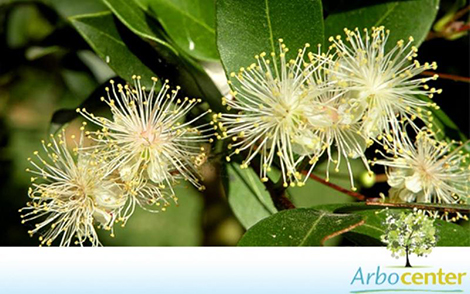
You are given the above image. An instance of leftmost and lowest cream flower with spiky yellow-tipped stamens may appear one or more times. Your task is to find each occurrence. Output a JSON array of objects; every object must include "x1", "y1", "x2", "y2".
[{"x1": 20, "y1": 127, "x2": 127, "y2": 246}]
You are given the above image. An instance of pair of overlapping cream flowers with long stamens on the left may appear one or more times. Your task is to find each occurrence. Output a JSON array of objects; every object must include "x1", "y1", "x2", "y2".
[{"x1": 20, "y1": 76, "x2": 213, "y2": 246}]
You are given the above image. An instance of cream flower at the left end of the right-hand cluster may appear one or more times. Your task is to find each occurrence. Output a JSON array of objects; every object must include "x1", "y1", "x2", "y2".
[{"x1": 218, "y1": 39, "x2": 324, "y2": 186}]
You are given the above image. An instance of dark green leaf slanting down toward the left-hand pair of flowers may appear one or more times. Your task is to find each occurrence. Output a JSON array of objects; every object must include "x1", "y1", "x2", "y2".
[{"x1": 70, "y1": 12, "x2": 156, "y2": 86}]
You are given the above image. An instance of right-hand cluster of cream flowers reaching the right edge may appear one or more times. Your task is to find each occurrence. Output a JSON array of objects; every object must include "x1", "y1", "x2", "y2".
[{"x1": 218, "y1": 27, "x2": 470, "y2": 211}]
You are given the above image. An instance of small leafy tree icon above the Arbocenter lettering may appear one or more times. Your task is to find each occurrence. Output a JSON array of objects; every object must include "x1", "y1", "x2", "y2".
[{"x1": 382, "y1": 210, "x2": 437, "y2": 267}]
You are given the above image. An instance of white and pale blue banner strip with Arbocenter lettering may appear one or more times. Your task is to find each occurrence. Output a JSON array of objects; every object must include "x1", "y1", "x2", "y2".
[{"x1": 0, "y1": 247, "x2": 470, "y2": 294}]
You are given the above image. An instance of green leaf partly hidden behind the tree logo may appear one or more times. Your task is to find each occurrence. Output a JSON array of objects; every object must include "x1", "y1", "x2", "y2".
[{"x1": 312, "y1": 203, "x2": 470, "y2": 246}]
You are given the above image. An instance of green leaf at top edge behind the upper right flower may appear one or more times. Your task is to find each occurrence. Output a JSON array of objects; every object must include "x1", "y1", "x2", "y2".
[{"x1": 325, "y1": 0, "x2": 439, "y2": 49}]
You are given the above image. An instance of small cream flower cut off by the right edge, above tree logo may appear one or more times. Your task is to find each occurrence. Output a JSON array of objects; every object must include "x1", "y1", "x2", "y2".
[{"x1": 375, "y1": 130, "x2": 470, "y2": 208}]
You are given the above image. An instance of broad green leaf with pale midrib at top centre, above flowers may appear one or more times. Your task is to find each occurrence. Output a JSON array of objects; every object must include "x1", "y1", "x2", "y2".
[{"x1": 216, "y1": 0, "x2": 324, "y2": 73}]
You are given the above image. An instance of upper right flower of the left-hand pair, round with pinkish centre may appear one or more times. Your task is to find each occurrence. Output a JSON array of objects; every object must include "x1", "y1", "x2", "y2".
[{"x1": 77, "y1": 76, "x2": 213, "y2": 198}]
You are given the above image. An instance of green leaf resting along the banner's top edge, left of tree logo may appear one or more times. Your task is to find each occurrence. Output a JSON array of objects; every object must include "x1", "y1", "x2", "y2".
[{"x1": 238, "y1": 208, "x2": 363, "y2": 246}]
